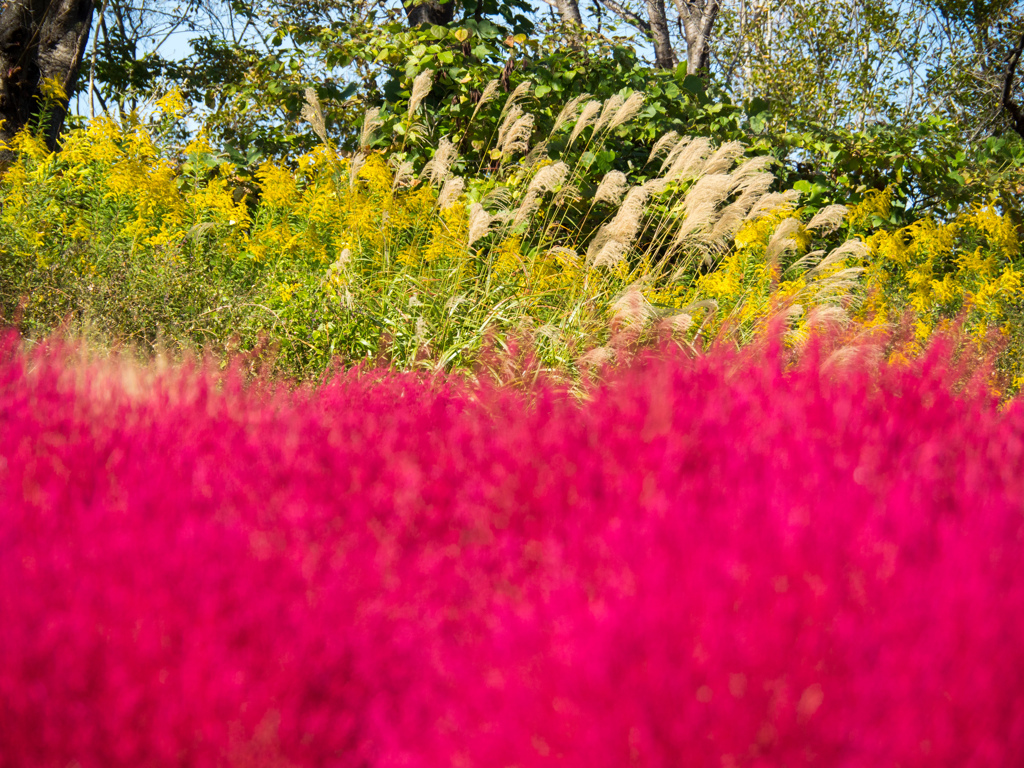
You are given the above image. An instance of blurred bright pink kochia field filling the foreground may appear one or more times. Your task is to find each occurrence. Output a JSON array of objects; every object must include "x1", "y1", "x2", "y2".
[{"x1": 0, "y1": 333, "x2": 1024, "y2": 768}]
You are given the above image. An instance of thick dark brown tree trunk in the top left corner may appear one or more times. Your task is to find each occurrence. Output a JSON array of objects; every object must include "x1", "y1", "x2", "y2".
[{"x1": 0, "y1": 0, "x2": 93, "y2": 167}]
